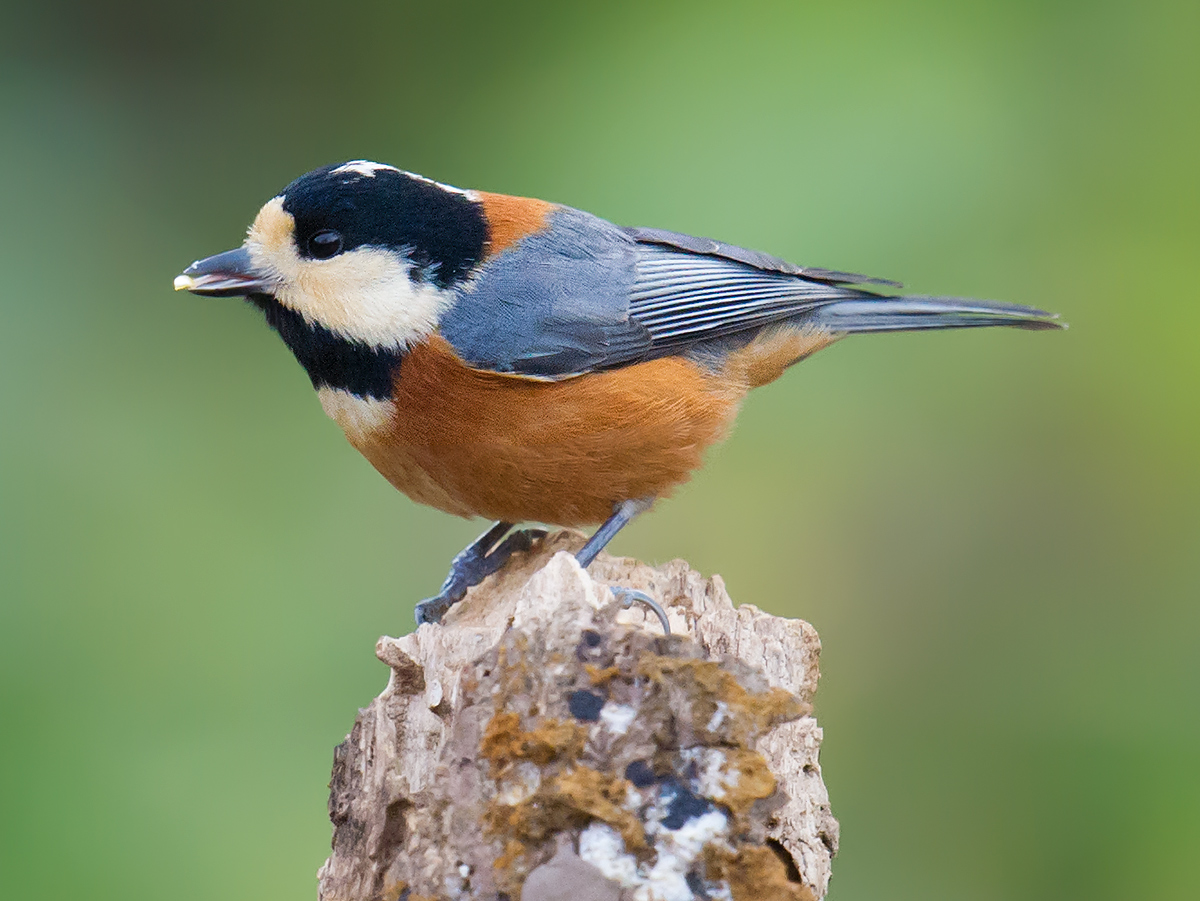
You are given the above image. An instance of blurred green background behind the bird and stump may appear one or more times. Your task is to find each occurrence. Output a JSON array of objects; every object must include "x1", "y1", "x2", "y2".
[{"x1": 0, "y1": 0, "x2": 1200, "y2": 901}]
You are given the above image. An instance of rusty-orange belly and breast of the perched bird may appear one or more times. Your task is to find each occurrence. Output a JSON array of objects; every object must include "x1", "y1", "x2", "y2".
[{"x1": 333, "y1": 337, "x2": 745, "y2": 525}]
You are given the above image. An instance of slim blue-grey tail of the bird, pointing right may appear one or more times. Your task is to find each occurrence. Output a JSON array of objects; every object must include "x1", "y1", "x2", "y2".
[{"x1": 809, "y1": 296, "x2": 1067, "y2": 334}]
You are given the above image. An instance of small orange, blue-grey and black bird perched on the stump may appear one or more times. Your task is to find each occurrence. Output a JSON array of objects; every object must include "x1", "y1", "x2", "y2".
[{"x1": 175, "y1": 160, "x2": 1060, "y2": 623}]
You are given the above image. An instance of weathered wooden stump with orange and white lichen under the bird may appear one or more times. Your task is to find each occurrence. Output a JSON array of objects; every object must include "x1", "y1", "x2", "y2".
[{"x1": 319, "y1": 533, "x2": 838, "y2": 901}]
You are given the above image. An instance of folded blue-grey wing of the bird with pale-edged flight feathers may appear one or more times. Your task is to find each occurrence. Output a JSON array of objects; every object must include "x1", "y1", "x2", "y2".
[{"x1": 442, "y1": 208, "x2": 882, "y2": 379}]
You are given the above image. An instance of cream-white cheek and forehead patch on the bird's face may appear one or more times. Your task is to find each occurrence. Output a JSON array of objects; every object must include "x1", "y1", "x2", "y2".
[{"x1": 246, "y1": 197, "x2": 454, "y2": 349}]
